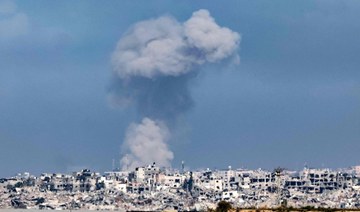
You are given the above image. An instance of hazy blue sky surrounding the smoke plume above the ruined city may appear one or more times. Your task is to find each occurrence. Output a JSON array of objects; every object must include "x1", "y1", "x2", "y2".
[{"x1": 0, "y1": 0, "x2": 360, "y2": 176}]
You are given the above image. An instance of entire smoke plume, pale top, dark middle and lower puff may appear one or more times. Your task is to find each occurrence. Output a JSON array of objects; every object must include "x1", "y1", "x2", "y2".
[{"x1": 112, "y1": 10, "x2": 240, "y2": 170}]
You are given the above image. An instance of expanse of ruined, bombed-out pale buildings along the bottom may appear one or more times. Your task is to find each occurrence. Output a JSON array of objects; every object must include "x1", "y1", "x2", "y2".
[{"x1": 0, "y1": 163, "x2": 360, "y2": 210}]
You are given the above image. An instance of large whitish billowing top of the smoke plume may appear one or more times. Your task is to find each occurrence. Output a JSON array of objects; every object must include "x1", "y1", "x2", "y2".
[{"x1": 112, "y1": 10, "x2": 240, "y2": 79}]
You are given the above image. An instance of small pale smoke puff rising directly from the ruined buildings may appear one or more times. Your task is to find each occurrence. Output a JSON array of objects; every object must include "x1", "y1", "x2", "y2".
[{"x1": 121, "y1": 118, "x2": 174, "y2": 170}]
